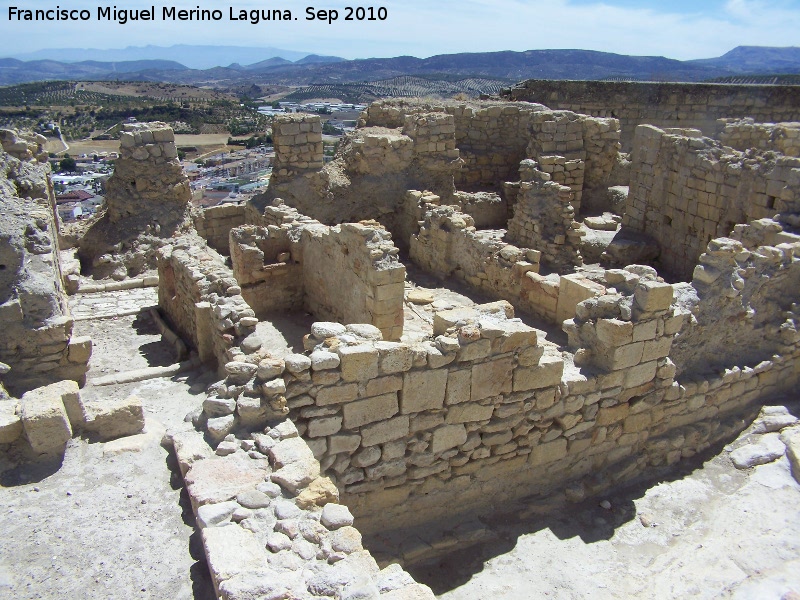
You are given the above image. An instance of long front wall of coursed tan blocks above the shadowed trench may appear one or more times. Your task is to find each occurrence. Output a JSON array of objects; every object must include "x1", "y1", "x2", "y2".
[{"x1": 284, "y1": 276, "x2": 798, "y2": 536}]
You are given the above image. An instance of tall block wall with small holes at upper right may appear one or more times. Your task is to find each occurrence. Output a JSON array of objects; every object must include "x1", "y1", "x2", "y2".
[{"x1": 623, "y1": 125, "x2": 800, "y2": 280}]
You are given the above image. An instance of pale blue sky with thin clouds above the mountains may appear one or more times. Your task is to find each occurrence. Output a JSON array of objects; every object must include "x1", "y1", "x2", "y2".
[{"x1": 0, "y1": 0, "x2": 800, "y2": 60}]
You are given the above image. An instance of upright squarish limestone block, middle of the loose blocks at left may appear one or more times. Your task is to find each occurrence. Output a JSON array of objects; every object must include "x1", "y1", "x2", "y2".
[{"x1": 20, "y1": 388, "x2": 72, "y2": 455}]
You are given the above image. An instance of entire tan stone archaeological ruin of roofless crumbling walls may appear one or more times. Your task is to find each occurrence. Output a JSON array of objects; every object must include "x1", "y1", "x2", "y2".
[{"x1": 0, "y1": 82, "x2": 800, "y2": 600}]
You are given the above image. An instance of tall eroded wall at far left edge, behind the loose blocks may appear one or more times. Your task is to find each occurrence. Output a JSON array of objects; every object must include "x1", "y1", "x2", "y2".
[{"x1": 0, "y1": 141, "x2": 92, "y2": 395}]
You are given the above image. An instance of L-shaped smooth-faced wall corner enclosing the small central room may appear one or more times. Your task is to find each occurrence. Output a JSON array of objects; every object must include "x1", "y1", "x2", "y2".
[{"x1": 231, "y1": 204, "x2": 405, "y2": 340}]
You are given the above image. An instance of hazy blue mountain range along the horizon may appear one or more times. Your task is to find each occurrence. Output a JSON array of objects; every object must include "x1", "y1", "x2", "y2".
[{"x1": 0, "y1": 46, "x2": 800, "y2": 88}]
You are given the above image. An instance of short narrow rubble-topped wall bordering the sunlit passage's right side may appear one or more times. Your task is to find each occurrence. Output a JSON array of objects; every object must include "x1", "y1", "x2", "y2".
[{"x1": 158, "y1": 237, "x2": 258, "y2": 369}]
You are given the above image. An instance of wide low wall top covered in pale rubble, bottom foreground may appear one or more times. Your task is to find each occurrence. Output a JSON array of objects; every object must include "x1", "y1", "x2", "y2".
[{"x1": 166, "y1": 421, "x2": 434, "y2": 600}]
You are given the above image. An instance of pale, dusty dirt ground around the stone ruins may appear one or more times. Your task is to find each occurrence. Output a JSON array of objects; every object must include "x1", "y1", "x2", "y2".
[{"x1": 0, "y1": 292, "x2": 800, "y2": 600}]
